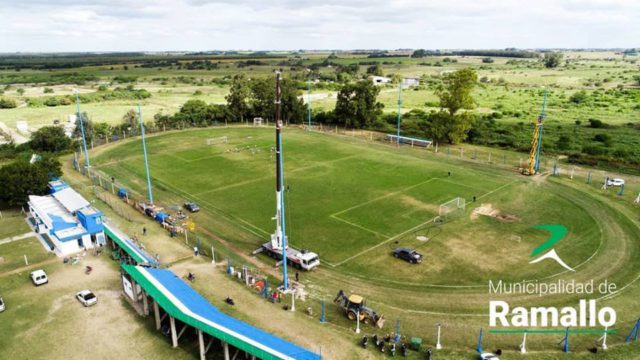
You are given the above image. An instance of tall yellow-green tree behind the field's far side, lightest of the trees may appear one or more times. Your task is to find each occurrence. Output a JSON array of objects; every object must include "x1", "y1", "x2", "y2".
[{"x1": 436, "y1": 68, "x2": 478, "y2": 116}]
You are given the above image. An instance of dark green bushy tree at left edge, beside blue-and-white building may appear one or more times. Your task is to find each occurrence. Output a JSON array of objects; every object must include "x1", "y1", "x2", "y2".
[{"x1": 0, "y1": 156, "x2": 62, "y2": 206}]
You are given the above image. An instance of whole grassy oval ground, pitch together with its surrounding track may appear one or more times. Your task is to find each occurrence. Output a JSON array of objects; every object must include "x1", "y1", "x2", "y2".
[{"x1": 92, "y1": 127, "x2": 640, "y2": 350}]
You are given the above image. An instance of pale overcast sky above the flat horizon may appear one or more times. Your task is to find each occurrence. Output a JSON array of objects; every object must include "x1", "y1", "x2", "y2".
[{"x1": 0, "y1": 0, "x2": 640, "y2": 52}]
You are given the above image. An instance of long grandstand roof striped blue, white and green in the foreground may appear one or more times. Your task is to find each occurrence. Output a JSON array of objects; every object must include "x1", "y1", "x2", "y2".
[{"x1": 122, "y1": 265, "x2": 321, "y2": 360}]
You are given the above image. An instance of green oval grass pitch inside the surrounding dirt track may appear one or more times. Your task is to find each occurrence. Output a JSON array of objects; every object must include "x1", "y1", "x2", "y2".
[{"x1": 93, "y1": 128, "x2": 602, "y2": 287}]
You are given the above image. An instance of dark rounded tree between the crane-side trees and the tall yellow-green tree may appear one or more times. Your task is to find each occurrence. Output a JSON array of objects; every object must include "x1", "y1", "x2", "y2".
[{"x1": 334, "y1": 81, "x2": 384, "y2": 128}]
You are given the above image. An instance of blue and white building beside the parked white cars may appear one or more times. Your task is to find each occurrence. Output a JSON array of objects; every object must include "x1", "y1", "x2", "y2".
[{"x1": 29, "y1": 180, "x2": 106, "y2": 256}]
